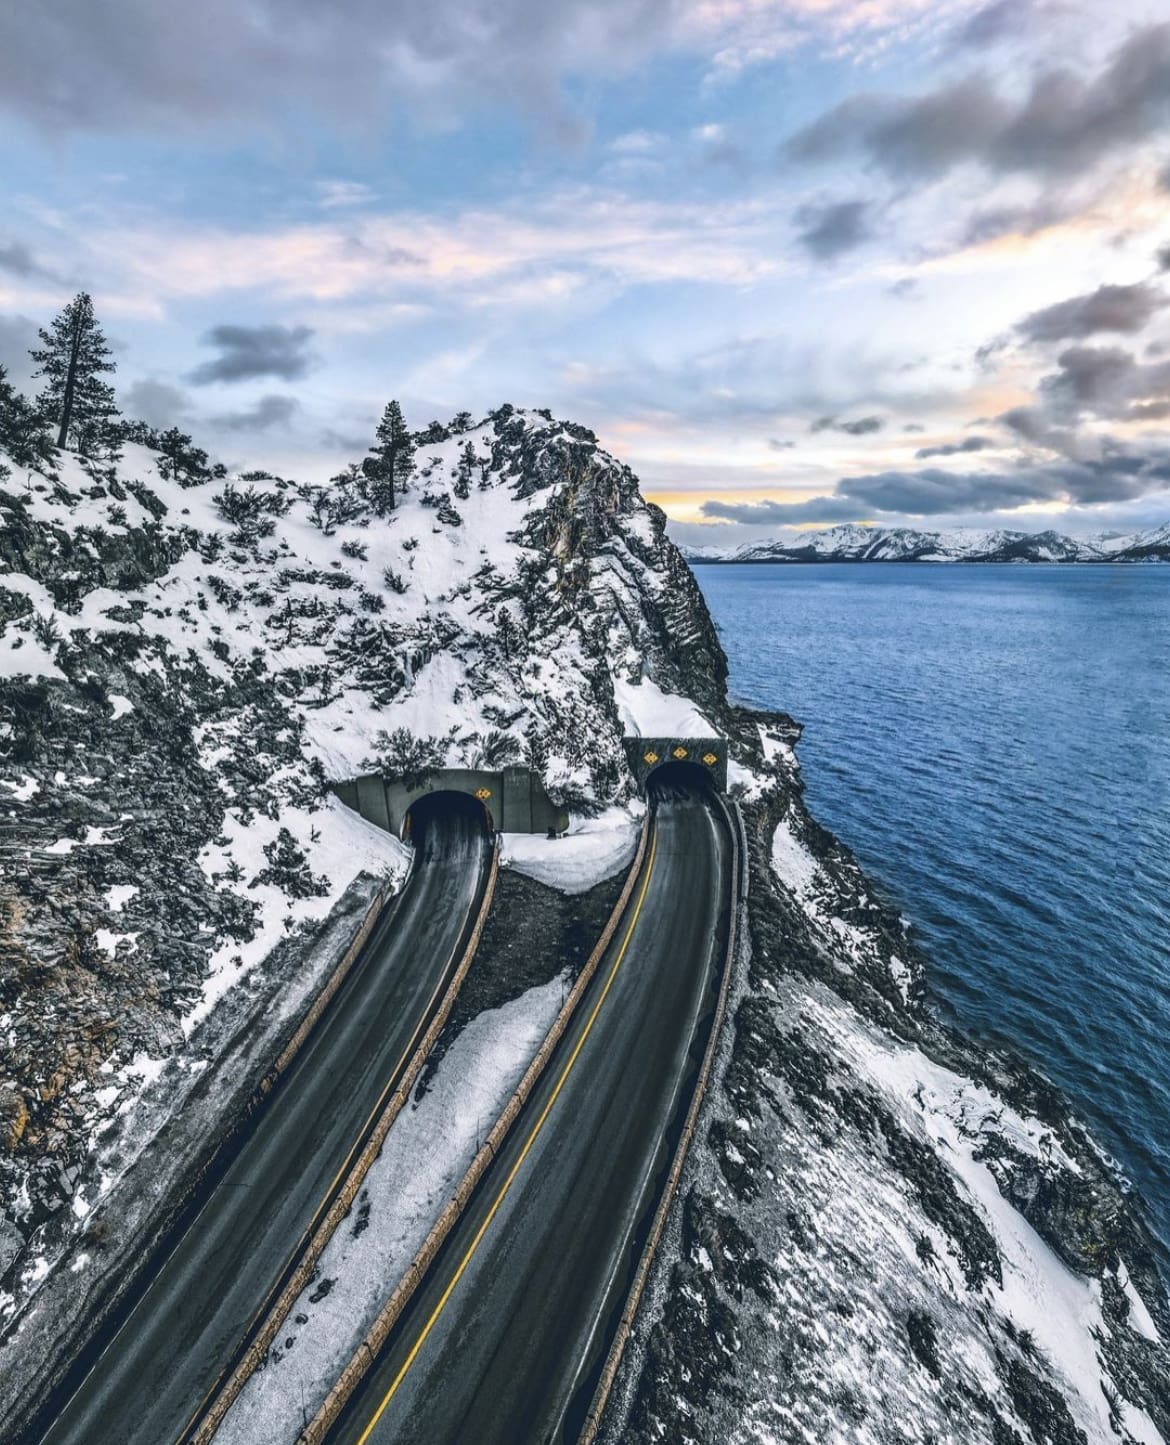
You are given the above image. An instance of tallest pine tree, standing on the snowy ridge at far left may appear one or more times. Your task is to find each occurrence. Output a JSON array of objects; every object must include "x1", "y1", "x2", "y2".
[{"x1": 29, "y1": 290, "x2": 118, "y2": 457}]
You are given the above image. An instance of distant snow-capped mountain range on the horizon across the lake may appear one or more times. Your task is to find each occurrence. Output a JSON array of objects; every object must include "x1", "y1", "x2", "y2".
[{"x1": 682, "y1": 522, "x2": 1170, "y2": 564}]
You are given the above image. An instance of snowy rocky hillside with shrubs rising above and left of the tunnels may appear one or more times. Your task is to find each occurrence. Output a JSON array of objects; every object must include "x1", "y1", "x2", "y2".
[{"x1": 0, "y1": 407, "x2": 722, "y2": 1273}]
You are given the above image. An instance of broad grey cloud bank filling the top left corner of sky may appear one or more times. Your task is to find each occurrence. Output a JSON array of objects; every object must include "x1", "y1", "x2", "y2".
[{"x1": 0, "y1": 0, "x2": 680, "y2": 137}]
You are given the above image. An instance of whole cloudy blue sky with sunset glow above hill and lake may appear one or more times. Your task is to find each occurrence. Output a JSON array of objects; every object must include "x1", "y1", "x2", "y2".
[{"x1": 0, "y1": 0, "x2": 1170, "y2": 545}]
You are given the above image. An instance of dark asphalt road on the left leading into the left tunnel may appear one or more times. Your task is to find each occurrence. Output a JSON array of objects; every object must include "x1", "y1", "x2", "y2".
[{"x1": 45, "y1": 815, "x2": 491, "y2": 1445}]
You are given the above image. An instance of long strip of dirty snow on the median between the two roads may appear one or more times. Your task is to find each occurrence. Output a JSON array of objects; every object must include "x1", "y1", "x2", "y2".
[{"x1": 217, "y1": 977, "x2": 563, "y2": 1445}]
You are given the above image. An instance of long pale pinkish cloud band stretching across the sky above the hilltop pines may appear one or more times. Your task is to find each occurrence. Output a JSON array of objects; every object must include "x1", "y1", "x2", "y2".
[{"x1": 84, "y1": 185, "x2": 783, "y2": 317}]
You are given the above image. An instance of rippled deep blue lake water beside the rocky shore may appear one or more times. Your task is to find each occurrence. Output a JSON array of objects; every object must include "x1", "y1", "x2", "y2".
[{"x1": 695, "y1": 564, "x2": 1170, "y2": 1248}]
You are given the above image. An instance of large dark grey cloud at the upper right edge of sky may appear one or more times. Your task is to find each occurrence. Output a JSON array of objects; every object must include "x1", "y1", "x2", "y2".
[{"x1": 784, "y1": 23, "x2": 1170, "y2": 179}]
